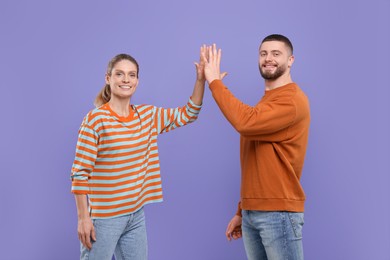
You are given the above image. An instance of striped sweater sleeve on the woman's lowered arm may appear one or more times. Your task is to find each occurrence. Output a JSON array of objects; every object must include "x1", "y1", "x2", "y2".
[{"x1": 71, "y1": 123, "x2": 98, "y2": 194}]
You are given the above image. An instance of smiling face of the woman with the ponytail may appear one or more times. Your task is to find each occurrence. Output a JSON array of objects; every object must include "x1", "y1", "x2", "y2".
[{"x1": 106, "y1": 60, "x2": 138, "y2": 99}]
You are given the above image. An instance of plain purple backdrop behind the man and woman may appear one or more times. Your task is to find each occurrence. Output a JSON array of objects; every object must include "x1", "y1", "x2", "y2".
[{"x1": 0, "y1": 0, "x2": 390, "y2": 260}]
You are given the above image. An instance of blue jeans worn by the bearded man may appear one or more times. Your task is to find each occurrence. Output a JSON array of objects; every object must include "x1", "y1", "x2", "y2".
[{"x1": 242, "y1": 210, "x2": 304, "y2": 260}]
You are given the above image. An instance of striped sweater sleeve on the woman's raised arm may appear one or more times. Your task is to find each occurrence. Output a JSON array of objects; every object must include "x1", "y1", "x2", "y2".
[{"x1": 154, "y1": 98, "x2": 201, "y2": 134}]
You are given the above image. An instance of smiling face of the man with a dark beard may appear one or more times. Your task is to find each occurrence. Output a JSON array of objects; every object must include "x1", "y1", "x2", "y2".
[{"x1": 259, "y1": 41, "x2": 294, "y2": 80}]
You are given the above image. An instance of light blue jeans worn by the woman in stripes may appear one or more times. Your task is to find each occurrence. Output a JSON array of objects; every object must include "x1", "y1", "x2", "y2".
[{"x1": 80, "y1": 208, "x2": 148, "y2": 260}]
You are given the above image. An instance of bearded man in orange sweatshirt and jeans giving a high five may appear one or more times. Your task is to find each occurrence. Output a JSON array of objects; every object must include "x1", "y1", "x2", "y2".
[{"x1": 204, "y1": 34, "x2": 310, "y2": 260}]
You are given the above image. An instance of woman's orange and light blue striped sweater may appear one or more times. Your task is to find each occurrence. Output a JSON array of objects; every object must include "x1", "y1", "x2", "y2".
[{"x1": 71, "y1": 99, "x2": 201, "y2": 218}]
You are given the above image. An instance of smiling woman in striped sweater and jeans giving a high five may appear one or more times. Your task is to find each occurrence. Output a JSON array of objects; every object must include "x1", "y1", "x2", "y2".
[{"x1": 72, "y1": 46, "x2": 206, "y2": 260}]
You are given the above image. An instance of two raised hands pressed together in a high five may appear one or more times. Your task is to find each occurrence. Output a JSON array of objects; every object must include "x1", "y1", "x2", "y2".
[{"x1": 197, "y1": 43, "x2": 227, "y2": 84}]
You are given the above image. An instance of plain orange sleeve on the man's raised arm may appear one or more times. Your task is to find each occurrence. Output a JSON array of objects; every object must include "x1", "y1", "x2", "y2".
[{"x1": 210, "y1": 80, "x2": 296, "y2": 142}]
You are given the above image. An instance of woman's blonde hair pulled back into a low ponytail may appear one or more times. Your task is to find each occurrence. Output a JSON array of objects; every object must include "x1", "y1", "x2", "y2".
[{"x1": 93, "y1": 53, "x2": 139, "y2": 107}]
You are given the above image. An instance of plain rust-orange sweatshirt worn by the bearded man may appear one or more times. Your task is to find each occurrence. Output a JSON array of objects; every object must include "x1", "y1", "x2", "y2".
[{"x1": 210, "y1": 80, "x2": 310, "y2": 215}]
